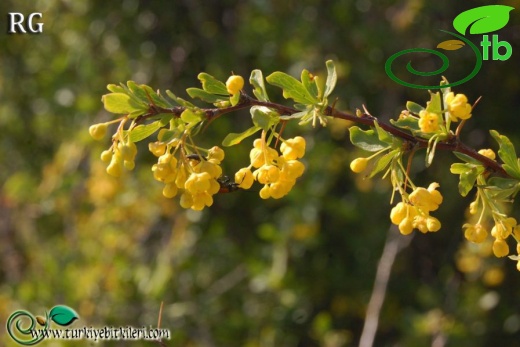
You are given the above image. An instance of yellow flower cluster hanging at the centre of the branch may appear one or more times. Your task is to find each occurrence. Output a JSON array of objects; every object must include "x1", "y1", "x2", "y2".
[{"x1": 235, "y1": 136, "x2": 305, "y2": 199}]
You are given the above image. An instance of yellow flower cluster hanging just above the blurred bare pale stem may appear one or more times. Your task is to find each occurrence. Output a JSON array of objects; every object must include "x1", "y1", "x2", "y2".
[{"x1": 390, "y1": 183, "x2": 442, "y2": 235}]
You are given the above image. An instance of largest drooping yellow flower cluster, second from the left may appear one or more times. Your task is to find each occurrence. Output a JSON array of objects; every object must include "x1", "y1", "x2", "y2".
[{"x1": 148, "y1": 142, "x2": 224, "y2": 211}]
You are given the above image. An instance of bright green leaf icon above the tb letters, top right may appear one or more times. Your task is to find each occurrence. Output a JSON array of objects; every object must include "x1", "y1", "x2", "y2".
[{"x1": 453, "y1": 5, "x2": 514, "y2": 35}]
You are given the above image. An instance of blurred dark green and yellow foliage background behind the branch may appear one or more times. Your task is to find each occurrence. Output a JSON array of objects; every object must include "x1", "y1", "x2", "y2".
[{"x1": 0, "y1": 0, "x2": 520, "y2": 347}]
